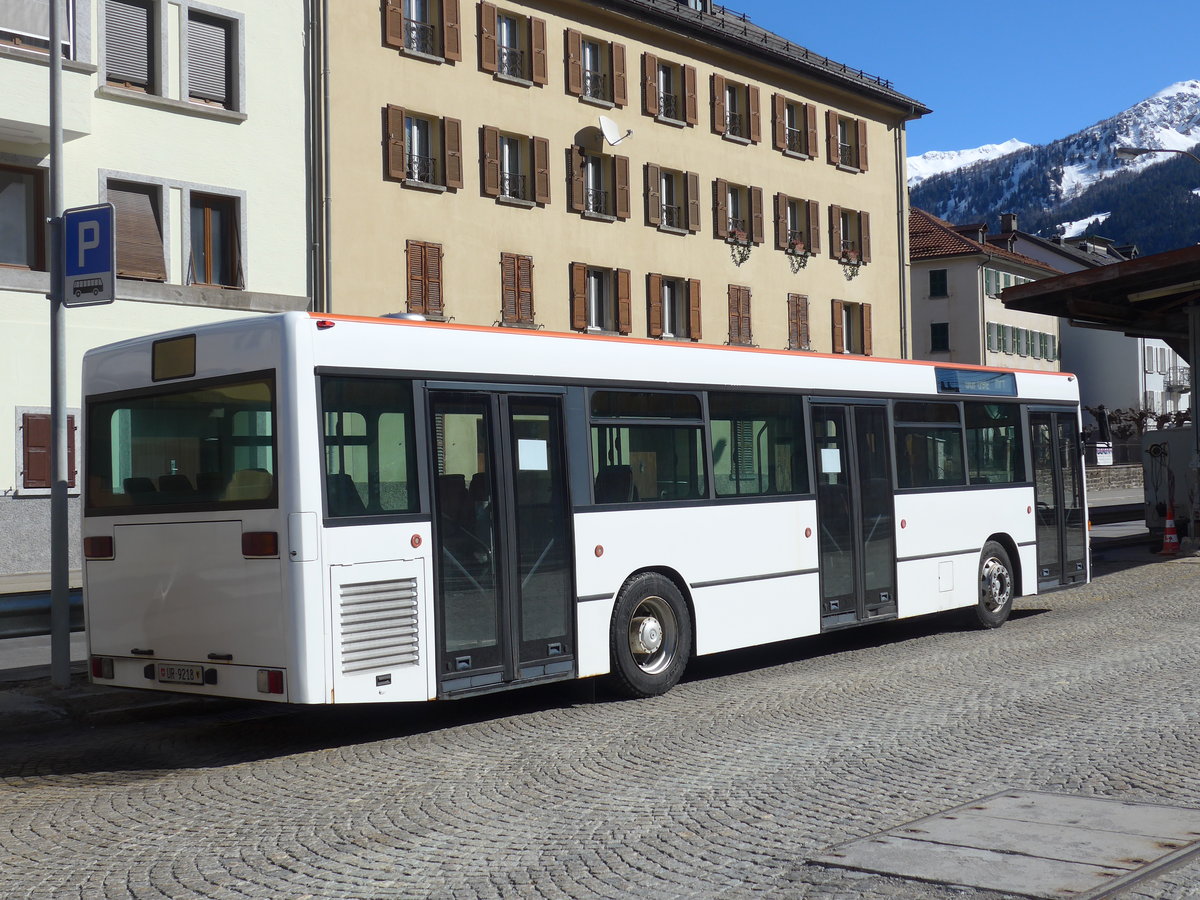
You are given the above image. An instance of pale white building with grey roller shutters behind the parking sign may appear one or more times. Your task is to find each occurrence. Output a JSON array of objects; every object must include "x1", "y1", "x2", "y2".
[{"x1": 0, "y1": 0, "x2": 311, "y2": 593}]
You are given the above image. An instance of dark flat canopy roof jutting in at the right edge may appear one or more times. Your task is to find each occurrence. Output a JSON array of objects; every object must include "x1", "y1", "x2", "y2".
[{"x1": 1001, "y1": 246, "x2": 1200, "y2": 468}]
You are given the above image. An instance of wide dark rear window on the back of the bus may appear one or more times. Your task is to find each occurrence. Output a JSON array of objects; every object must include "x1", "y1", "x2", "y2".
[{"x1": 86, "y1": 376, "x2": 278, "y2": 514}]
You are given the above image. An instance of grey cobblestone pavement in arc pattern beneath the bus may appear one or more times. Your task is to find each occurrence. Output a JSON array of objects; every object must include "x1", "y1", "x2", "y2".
[{"x1": 0, "y1": 558, "x2": 1200, "y2": 900}]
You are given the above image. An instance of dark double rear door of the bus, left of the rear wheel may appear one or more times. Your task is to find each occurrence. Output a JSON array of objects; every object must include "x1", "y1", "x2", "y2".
[{"x1": 430, "y1": 390, "x2": 575, "y2": 696}]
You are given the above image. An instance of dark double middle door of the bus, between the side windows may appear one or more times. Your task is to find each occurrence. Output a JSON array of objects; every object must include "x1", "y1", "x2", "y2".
[{"x1": 812, "y1": 403, "x2": 896, "y2": 630}]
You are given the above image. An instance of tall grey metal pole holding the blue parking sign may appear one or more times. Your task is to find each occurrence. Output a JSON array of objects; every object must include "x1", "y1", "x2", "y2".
[{"x1": 50, "y1": 0, "x2": 71, "y2": 688}]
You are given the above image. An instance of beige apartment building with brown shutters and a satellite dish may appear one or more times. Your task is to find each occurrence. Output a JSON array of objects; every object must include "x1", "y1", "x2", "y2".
[{"x1": 314, "y1": 0, "x2": 929, "y2": 356}]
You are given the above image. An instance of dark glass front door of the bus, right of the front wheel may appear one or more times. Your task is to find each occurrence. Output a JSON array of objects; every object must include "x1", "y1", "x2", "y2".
[{"x1": 1030, "y1": 410, "x2": 1087, "y2": 590}]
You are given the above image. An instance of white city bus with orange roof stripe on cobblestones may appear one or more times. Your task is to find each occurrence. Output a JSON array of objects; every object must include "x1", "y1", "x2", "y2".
[{"x1": 83, "y1": 313, "x2": 1088, "y2": 703}]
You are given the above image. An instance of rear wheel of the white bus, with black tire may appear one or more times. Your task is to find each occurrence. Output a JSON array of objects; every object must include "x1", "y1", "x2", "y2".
[{"x1": 608, "y1": 572, "x2": 692, "y2": 698}]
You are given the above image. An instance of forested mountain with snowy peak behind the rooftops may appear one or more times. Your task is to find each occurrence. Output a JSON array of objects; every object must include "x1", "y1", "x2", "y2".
[{"x1": 910, "y1": 79, "x2": 1200, "y2": 252}]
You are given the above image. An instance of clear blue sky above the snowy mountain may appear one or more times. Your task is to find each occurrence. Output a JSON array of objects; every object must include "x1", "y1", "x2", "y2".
[{"x1": 724, "y1": 0, "x2": 1200, "y2": 156}]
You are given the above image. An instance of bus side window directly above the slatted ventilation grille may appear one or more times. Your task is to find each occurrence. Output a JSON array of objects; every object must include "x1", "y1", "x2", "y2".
[{"x1": 320, "y1": 376, "x2": 420, "y2": 518}]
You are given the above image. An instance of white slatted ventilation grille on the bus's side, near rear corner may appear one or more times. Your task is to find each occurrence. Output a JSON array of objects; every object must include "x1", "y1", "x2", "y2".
[{"x1": 341, "y1": 578, "x2": 420, "y2": 674}]
